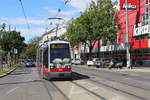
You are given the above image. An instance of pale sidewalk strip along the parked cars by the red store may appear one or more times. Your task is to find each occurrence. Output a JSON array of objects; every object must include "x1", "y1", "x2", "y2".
[{"x1": 73, "y1": 65, "x2": 150, "y2": 72}]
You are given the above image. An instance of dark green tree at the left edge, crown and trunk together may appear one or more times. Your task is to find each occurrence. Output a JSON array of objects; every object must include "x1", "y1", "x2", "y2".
[{"x1": 0, "y1": 27, "x2": 26, "y2": 66}]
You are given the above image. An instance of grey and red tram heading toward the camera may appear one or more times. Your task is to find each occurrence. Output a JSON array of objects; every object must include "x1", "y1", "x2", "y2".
[{"x1": 37, "y1": 40, "x2": 72, "y2": 80}]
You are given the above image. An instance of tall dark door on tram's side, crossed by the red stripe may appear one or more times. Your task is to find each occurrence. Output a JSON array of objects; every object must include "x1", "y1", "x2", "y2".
[{"x1": 43, "y1": 47, "x2": 49, "y2": 78}]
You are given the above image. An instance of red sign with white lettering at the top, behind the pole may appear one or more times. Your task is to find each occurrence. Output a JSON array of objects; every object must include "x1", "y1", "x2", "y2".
[{"x1": 120, "y1": 0, "x2": 137, "y2": 10}]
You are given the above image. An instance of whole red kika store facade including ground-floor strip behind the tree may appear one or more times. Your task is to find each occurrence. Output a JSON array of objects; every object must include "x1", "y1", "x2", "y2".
[{"x1": 74, "y1": 0, "x2": 150, "y2": 66}]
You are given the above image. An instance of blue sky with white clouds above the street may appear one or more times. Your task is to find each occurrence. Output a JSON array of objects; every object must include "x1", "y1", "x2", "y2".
[{"x1": 0, "y1": 0, "x2": 116, "y2": 41}]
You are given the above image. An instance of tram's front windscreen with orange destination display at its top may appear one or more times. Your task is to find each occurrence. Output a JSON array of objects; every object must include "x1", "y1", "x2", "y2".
[{"x1": 50, "y1": 44, "x2": 70, "y2": 63}]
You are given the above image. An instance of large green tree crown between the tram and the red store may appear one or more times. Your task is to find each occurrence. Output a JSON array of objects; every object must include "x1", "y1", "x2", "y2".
[{"x1": 63, "y1": 0, "x2": 118, "y2": 53}]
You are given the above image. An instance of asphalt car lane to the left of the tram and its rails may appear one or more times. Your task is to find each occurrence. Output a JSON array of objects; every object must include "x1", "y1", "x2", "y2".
[{"x1": 0, "y1": 66, "x2": 49, "y2": 100}]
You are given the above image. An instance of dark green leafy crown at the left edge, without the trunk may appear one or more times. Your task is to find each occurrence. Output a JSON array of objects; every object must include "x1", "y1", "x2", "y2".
[{"x1": 0, "y1": 31, "x2": 26, "y2": 54}]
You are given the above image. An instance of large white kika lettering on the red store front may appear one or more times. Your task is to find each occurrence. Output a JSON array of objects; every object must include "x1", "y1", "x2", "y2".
[{"x1": 133, "y1": 23, "x2": 150, "y2": 36}]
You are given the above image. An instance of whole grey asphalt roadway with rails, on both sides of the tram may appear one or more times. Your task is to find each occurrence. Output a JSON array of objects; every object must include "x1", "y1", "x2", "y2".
[{"x1": 0, "y1": 66, "x2": 150, "y2": 100}]
